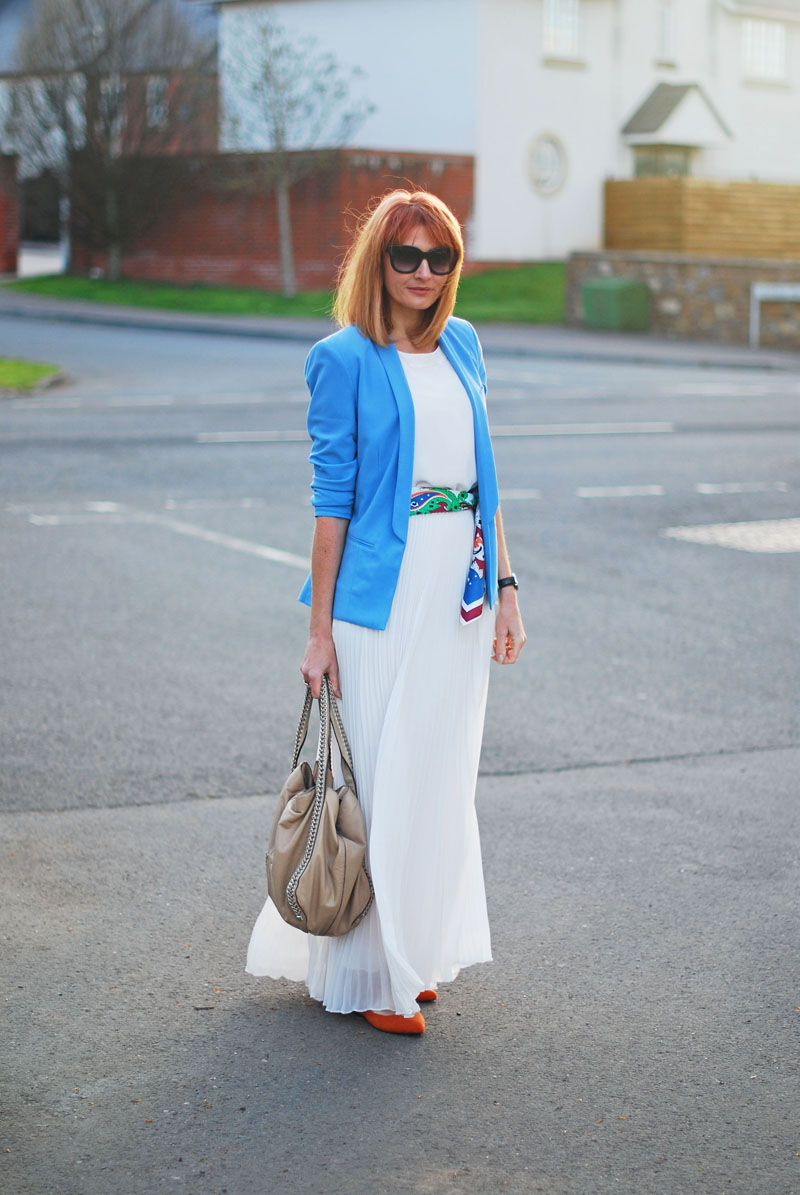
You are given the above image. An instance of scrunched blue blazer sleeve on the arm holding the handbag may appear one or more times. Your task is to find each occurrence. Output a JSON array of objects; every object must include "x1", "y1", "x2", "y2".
[{"x1": 305, "y1": 341, "x2": 359, "y2": 519}]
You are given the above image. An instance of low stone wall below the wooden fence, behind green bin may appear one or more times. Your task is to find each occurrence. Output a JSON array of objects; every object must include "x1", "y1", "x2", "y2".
[{"x1": 567, "y1": 251, "x2": 800, "y2": 349}]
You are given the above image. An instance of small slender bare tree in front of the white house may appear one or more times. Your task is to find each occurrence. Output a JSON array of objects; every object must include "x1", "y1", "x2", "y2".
[{"x1": 225, "y1": 13, "x2": 374, "y2": 296}]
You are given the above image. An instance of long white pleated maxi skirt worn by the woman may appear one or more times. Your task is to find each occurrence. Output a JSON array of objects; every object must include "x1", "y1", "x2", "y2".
[{"x1": 246, "y1": 510, "x2": 494, "y2": 1016}]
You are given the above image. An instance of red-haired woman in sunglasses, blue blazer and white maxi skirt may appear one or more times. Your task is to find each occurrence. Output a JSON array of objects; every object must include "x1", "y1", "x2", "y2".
[{"x1": 248, "y1": 191, "x2": 525, "y2": 1034}]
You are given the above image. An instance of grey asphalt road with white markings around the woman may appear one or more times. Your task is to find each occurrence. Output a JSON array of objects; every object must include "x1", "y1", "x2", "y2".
[{"x1": 0, "y1": 319, "x2": 800, "y2": 1195}]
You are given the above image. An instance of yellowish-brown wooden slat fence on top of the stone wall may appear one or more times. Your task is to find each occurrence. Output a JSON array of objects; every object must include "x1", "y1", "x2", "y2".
[{"x1": 603, "y1": 178, "x2": 800, "y2": 262}]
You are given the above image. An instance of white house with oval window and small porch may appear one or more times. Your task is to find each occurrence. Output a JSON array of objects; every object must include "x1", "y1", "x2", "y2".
[{"x1": 208, "y1": 0, "x2": 800, "y2": 261}]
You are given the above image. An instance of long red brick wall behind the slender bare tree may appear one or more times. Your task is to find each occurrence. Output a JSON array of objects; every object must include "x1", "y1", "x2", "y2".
[{"x1": 73, "y1": 149, "x2": 474, "y2": 290}]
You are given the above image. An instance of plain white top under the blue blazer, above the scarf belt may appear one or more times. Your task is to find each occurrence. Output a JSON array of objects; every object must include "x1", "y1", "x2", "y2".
[{"x1": 397, "y1": 349, "x2": 477, "y2": 490}]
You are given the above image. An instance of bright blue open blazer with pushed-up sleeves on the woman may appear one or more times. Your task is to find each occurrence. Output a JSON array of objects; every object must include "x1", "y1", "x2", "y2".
[{"x1": 299, "y1": 317, "x2": 497, "y2": 631}]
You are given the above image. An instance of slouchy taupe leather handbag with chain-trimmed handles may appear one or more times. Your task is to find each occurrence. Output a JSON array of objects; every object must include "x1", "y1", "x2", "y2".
[{"x1": 267, "y1": 675, "x2": 373, "y2": 937}]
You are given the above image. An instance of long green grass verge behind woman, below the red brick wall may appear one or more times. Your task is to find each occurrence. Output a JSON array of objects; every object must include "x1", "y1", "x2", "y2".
[{"x1": 7, "y1": 262, "x2": 564, "y2": 324}]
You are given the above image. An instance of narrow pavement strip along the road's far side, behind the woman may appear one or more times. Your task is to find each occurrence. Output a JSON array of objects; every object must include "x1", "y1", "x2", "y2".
[{"x1": 0, "y1": 287, "x2": 800, "y2": 372}]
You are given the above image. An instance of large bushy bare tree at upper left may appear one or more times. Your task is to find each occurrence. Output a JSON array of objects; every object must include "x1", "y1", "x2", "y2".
[{"x1": 4, "y1": 0, "x2": 215, "y2": 277}]
